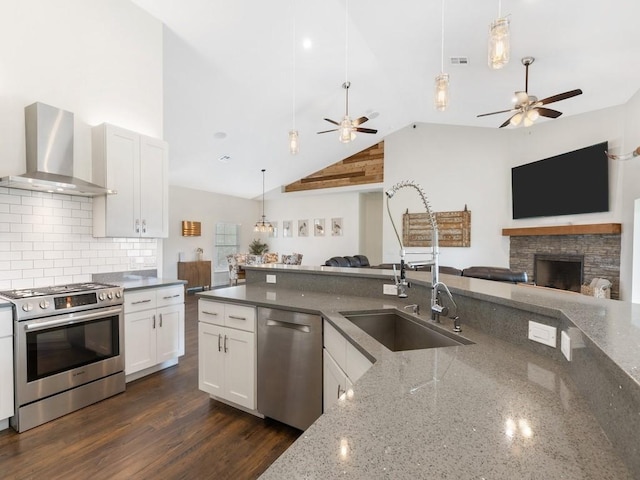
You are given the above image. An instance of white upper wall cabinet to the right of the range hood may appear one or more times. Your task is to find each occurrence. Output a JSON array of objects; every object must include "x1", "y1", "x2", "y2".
[{"x1": 92, "y1": 124, "x2": 169, "y2": 238}]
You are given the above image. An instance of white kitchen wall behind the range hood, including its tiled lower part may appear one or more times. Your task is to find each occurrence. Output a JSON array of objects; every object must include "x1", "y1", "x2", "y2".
[{"x1": 0, "y1": 0, "x2": 163, "y2": 288}]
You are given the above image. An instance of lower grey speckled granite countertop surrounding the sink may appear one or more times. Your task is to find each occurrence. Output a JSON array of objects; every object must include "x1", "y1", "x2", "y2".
[{"x1": 198, "y1": 284, "x2": 637, "y2": 479}]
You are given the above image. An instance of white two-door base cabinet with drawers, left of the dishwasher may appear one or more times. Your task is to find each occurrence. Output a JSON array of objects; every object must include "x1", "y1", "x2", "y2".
[{"x1": 198, "y1": 299, "x2": 256, "y2": 410}]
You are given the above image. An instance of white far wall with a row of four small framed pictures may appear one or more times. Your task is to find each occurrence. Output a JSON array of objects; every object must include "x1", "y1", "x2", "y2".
[{"x1": 265, "y1": 189, "x2": 360, "y2": 265}]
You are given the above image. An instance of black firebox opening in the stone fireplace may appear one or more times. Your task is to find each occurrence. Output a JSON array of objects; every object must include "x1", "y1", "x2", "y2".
[{"x1": 533, "y1": 254, "x2": 584, "y2": 292}]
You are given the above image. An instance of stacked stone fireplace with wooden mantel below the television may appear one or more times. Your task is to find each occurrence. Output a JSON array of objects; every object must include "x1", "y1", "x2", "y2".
[{"x1": 502, "y1": 223, "x2": 621, "y2": 299}]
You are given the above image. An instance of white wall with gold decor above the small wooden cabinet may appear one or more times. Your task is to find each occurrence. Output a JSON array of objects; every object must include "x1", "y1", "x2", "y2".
[{"x1": 162, "y1": 186, "x2": 260, "y2": 285}]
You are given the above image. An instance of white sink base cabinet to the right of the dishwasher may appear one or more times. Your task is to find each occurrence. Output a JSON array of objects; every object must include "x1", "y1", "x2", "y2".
[{"x1": 322, "y1": 320, "x2": 372, "y2": 411}]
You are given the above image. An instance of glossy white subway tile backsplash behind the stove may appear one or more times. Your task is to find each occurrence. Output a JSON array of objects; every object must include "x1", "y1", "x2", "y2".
[{"x1": 0, "y1": 187, "x2": 161, "y2": 290}]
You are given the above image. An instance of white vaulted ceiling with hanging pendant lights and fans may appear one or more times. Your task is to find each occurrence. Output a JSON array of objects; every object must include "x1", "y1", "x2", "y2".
[{"x1": 133, "y1": 0, "x2": 640, "y2": 198}]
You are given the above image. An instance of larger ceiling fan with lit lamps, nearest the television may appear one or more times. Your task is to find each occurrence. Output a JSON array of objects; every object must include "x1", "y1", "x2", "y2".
[{"x1": 478, "y1": 57, "x2": 582, "y2": 128}]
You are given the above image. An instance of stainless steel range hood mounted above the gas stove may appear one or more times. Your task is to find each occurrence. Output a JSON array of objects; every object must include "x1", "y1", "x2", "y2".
[{"x1": 0, "y1": 102, "x2": 115, "y2": 197}]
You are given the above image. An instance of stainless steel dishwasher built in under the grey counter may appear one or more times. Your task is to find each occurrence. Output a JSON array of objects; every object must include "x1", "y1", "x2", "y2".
[{"x1": 257, "y1": 308, "x2": 322, "y2": 430}]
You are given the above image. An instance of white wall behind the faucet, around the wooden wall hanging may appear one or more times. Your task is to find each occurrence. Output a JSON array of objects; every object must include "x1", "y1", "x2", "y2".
[{"x1": 383, "y1": 123, "x2": 510, "y2": 268}]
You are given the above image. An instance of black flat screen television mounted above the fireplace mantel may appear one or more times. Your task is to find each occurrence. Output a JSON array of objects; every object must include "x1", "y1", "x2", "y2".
[{"x1": 511, "y1": 142, "x2": 609, "y2": 219}]
